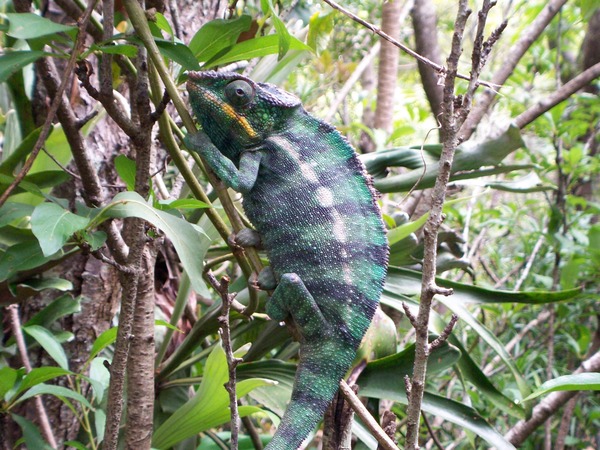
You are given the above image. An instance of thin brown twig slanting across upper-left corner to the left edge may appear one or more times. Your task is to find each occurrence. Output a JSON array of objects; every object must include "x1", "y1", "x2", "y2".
[{"x1": 0, "y1": 0, "x2": 98, "y2": 206}]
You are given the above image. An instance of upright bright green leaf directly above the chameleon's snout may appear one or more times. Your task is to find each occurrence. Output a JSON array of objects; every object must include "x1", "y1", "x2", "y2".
[{"x1": 189, "y1": 15, "x2": 252, "y2": 62}]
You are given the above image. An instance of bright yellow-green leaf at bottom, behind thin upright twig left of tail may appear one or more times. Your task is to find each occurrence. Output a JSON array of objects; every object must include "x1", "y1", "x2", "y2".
[{"x1": 152, "y1": 345, "x2": 269, "y2": 449}]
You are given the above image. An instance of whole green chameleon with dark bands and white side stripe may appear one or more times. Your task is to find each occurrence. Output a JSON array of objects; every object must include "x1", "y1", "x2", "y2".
[{"x1": 187, "y1": 71, "x2": 389, "y2": 450}]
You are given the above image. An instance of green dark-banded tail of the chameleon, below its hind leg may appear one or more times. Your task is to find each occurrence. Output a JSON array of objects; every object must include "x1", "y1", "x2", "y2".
[{"x1": 265, "y1": 340, "x2": 356, "y2": 450}]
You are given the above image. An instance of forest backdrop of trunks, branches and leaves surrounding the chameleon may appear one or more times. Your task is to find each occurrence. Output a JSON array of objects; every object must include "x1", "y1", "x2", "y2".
[{"x1": 0, "y1": 0, "x2": 600, "y2": 449}]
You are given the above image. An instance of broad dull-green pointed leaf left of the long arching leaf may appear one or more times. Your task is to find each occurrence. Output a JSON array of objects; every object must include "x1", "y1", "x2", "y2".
[{"x1": 31, "y1": 203, "x2": 90, "y2": 256}]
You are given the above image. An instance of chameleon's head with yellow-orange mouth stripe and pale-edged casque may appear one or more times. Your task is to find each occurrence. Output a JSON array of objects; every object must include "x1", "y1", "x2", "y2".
[{"x1": 187, "y1": 71, "x2": 300, "y2": 156}]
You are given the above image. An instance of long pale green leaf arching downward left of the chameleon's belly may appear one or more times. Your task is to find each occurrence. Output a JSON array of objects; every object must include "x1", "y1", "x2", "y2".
[{"x1": 96, "y1": 192, "x2": 211, "y2": 292}]
